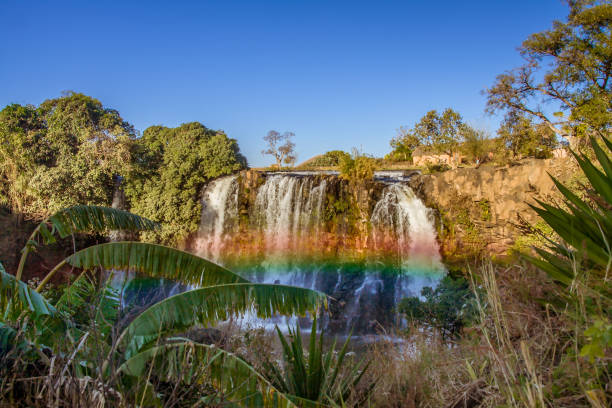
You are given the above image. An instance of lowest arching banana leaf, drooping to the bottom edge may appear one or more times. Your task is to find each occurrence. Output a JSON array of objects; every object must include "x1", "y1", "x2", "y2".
[{"x1": 118, "y1": 342, "x2": 296, "y2": 408}]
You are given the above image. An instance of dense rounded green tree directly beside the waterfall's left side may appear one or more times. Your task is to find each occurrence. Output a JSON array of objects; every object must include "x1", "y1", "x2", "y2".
[{"x1": 125, "y1": 122, "x2": 247, "y2": 245}]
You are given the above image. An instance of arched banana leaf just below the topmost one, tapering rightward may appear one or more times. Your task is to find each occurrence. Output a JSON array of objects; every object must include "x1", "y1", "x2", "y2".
[{"x1": 65, "y1": 242, "x2": 248, "y2": 286}]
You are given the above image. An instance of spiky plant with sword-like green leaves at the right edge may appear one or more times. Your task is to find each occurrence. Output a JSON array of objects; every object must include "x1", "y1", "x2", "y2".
[{"x1": 527, "y1": 138, "x2": 612, "y2": 406}]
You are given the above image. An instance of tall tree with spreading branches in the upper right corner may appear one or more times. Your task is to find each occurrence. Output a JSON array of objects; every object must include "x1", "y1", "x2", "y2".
[{"x1": 486, "y1": 0, "x2": 612, "y2": 143}]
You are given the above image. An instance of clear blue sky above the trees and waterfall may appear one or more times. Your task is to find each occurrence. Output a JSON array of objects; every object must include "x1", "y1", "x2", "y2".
[{"x1": 0, "y1": 0, "x2": 567, "y2": 166}]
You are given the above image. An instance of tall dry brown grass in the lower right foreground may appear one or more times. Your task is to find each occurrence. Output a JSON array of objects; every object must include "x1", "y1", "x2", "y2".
[{"x1": 358, "y1": 263, "x2": 611, "y2": 408}]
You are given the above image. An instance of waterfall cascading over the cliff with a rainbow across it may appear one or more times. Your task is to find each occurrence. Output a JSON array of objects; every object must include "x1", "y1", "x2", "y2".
[{"x1": 195, "y1": 174, "x2": 444, "y2": 332}]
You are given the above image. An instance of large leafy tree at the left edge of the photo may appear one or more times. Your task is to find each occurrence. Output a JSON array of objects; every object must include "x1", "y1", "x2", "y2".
[{"x1": 0, "y1": 92, "x2": 135, "y2": 219}]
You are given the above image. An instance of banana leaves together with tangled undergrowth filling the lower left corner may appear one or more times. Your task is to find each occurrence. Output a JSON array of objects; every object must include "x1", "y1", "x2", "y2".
[{"x1": 0, "y1": 206, "x2": 325, "y2": 406}]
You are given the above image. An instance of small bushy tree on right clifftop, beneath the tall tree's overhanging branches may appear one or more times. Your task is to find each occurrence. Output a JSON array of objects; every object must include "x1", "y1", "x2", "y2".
[{"x1": 497, "y1": 112, "x2": 557, "y2": 159}]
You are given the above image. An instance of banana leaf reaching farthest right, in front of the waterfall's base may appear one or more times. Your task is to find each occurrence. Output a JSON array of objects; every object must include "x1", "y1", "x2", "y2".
[{"x1": 121, "y1": 283, "x2": 327, "y2": 354}]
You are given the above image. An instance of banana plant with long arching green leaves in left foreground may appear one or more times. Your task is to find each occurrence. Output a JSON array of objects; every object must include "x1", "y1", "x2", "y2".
[{"x1": 0, "y1": 206, "x2": 327, "y2": 407}]
